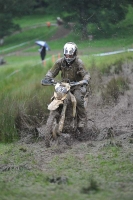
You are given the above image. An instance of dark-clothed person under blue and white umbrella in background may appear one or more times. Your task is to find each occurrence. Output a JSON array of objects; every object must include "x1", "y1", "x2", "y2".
[{"x1": 35, "y1": 41, "x2": 50, "y2": 65}]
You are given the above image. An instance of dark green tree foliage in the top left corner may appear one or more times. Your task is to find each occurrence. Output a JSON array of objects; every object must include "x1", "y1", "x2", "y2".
[{"x1": 0, "y1": 0, "x2": 35, "y2": 39}]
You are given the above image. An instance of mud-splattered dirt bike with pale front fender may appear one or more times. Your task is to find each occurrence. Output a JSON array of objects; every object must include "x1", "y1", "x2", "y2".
[{"x1": 41, "y1": 79, "x2": 88, "y2": 147}]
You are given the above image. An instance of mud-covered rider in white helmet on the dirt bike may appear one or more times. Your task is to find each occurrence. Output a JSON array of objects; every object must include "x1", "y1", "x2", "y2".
[{"x1": 42, "y1": 42, "x2": 90, "y2": 132}]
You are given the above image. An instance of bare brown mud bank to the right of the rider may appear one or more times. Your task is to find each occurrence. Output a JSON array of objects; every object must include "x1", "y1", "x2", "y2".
[{"x1": 87, "y1": 62, "x2": 133, "y2": 140}]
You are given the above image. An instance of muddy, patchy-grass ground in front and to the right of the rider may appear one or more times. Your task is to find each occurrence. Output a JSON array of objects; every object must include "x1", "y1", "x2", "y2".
[{"x1": 0, "y1": 56, "x2": 133, "y2": 200}]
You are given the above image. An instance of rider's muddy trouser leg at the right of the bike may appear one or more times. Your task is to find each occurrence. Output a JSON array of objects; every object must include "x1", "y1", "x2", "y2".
[{"x1": 72, "y1": 89, "x2": 86, "y2": 127}]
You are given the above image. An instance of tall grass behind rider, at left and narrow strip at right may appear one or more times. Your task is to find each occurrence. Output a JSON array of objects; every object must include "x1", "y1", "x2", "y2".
[{"x1": 0, "y1": 48, "x2": 133, "y2": 142}]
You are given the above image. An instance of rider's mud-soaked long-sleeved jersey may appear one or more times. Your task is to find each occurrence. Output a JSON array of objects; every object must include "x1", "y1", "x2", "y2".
[{"x1": 46, "y1": 57, "x2": 90, "y2": 82}]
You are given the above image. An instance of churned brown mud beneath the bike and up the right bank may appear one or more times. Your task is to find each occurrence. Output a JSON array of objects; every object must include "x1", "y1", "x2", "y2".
[{"x1": 20, "y1": 62, "x2": 133, "y2": 170}]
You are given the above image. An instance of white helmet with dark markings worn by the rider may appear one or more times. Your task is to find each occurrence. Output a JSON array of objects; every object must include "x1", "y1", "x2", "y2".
[{"x1": 63, "y1": 42, "x2": 78, "y2": 64}]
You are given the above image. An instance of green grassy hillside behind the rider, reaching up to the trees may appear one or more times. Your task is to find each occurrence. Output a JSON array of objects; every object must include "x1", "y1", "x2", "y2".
[{"x1": 0, "y1": 7, "x2": 133, "y2": 142}]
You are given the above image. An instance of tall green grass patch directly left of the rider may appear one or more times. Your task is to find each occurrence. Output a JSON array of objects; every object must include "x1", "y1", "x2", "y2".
[{"x1": 0, "y1": 62, "x2": 52, "y2": 142}]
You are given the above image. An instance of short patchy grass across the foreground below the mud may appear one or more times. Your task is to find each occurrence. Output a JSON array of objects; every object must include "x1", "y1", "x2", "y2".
[{"x1": 0, "y1": 143, "x2": 133, "y2": 200}]
